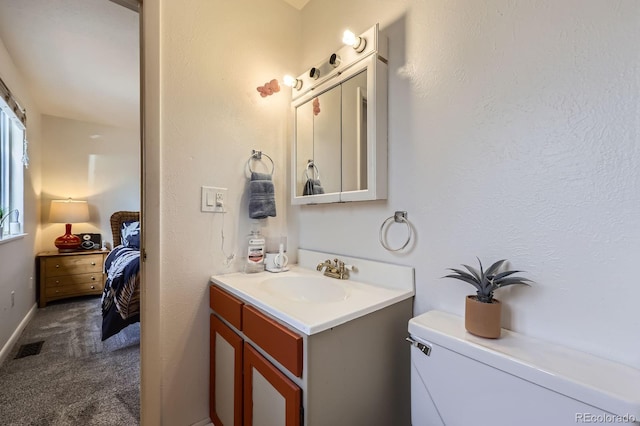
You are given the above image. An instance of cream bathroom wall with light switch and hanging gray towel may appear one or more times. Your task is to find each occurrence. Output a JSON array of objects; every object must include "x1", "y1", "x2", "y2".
[{"x1": 149, "y1": 0, "x2": 300, "y2": 425}]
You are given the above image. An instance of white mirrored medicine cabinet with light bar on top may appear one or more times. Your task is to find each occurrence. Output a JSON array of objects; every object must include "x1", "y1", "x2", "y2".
[{"x1": 291, "y1": 24, "x2": 387, "y2": 204}]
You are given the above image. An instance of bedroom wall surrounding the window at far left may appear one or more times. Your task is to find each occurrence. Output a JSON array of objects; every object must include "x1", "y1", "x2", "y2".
[{"x1": 0, "y1": 36, "x2": 41, "y2": 362}]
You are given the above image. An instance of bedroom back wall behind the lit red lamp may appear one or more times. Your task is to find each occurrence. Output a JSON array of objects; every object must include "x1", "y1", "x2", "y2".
[{"x1": 41, "y1": 115, "x2": 140, "y2": 250}]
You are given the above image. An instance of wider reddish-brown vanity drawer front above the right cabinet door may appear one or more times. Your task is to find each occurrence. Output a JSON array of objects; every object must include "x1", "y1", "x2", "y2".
[{"x1": 242, "y1": 305, "x2": 302, "y2": 377}]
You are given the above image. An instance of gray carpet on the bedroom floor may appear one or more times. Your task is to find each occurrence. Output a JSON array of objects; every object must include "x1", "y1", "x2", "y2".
[{"x1": 0, "y1": 296, "x2": 140, "y2": 426}]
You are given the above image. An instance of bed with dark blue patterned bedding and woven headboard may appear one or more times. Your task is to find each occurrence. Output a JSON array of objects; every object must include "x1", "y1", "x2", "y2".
[{"x1": 102, "y1": 211, "x2": 140, "y2": 341}]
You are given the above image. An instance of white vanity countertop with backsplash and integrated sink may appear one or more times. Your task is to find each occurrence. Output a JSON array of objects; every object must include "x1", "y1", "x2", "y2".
[{"x1": 211, "y1": 250, "x2": 415, "y2": 335}]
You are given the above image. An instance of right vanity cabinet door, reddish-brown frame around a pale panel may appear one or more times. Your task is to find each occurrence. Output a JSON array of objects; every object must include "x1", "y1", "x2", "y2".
[{"x1": 244, "y1": 342, "x2": 302, "y2": 426}]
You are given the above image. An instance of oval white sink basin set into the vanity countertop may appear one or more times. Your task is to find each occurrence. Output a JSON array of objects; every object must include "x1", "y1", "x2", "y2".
[{"x1": 262, "y1": 276, "x2": 350, "y2": 303}]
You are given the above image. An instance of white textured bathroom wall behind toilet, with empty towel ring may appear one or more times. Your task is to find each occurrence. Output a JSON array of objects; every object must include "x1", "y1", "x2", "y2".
[{"x1": 298, "y1": 0, "x2": 640, "y2": 368}]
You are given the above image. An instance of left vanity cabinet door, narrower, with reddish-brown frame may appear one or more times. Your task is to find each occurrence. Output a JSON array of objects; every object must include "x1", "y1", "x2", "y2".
[{"x1": 209, "y1": 314, "x2": 243, "y2": 426}]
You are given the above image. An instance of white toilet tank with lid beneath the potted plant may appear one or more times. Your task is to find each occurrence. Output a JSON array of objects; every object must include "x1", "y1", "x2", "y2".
[{"x1": 407, "y1": 311, "x2": 640, "y2": 426}]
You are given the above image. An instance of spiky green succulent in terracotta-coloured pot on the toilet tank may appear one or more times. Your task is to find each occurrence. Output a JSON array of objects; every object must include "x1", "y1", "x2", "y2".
[{"x1": 443, "y1": 259, "x2": 532, "y2": 339}]
